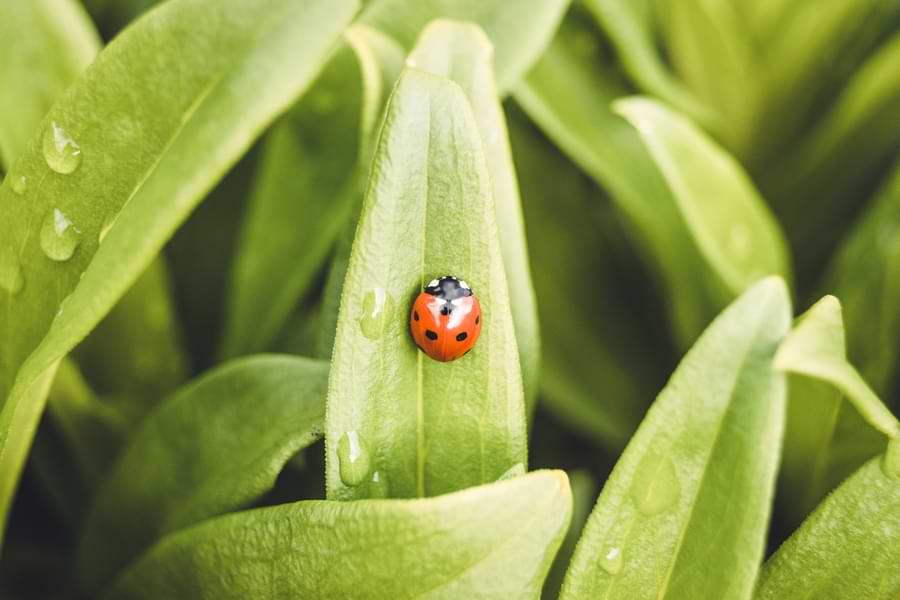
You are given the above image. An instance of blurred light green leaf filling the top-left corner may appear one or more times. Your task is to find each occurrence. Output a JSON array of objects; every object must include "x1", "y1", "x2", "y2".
[{"x1": 0, "y1": 0, "x2": 100, "y2": 169}]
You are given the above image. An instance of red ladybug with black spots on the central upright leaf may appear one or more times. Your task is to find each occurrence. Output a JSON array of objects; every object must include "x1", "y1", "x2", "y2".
[{"x1": 409, "y1": 275, "x2": 481, "y2": 362}]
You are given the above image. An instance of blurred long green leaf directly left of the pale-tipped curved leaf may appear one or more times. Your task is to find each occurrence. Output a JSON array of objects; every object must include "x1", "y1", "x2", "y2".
[{"x1": 515, "y1": 12, "x2": 730, "y2": 346}]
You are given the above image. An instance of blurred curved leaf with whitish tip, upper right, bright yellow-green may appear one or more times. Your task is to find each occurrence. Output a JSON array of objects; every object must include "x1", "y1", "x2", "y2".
[{"x1": 615, "y1": 98, "x2": 789, "y2": 295}]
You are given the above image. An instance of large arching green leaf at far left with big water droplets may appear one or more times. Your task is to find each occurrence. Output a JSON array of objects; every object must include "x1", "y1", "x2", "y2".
[{"x1": 0, "y1": 0, "x2": 355, "y2": 548}]
